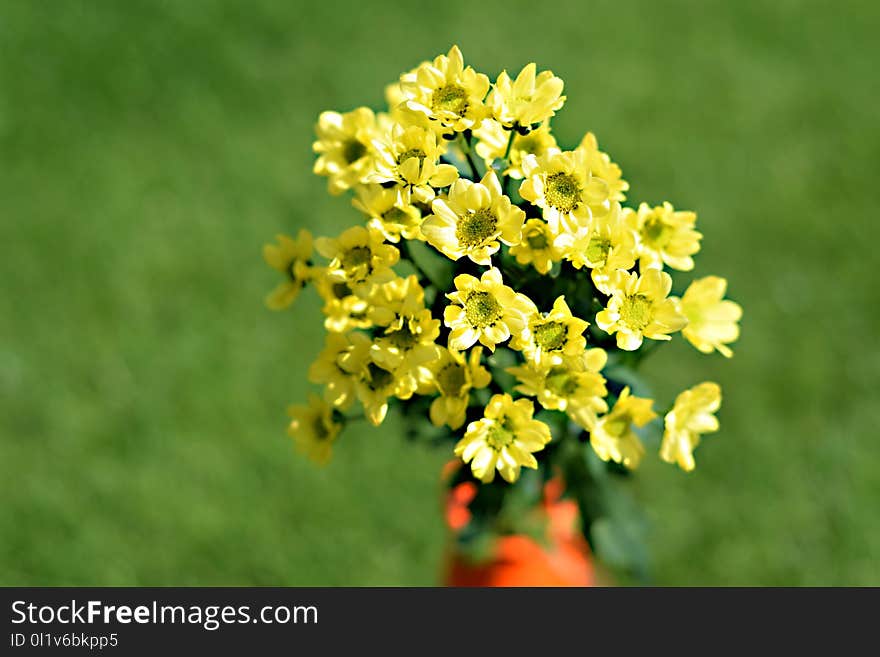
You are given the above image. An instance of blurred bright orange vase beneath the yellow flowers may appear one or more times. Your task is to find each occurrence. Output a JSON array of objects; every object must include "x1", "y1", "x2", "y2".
[{"x1": 443, "y1": 468, "x2": 594, "y2": 586}]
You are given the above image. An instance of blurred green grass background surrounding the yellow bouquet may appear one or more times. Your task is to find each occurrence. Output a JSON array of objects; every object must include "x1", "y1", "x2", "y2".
[{"x1": 0, "y1": 0, "x2": 880, "y2": 585}]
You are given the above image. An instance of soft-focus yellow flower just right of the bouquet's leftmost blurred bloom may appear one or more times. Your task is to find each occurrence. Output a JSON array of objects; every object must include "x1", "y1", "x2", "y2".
[{"x1": 315, "y1": 226, "x2": 400, "y2": 296}]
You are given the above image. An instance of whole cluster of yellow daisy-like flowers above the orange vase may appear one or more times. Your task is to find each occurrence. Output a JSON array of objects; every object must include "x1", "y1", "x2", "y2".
[{"x1": 264, "y1": 46, "x2": 742, "y2": 482}]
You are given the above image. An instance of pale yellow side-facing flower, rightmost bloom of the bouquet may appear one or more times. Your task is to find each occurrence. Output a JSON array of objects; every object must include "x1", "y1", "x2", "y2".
[{"x1": 681, "y1": 276, "x2": 742, "y2": 358}]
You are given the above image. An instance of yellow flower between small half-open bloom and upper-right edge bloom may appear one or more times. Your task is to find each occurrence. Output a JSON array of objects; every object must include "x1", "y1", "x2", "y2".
[{"x1": 557, "y1": 201, "x2": 637, "y2": 294}]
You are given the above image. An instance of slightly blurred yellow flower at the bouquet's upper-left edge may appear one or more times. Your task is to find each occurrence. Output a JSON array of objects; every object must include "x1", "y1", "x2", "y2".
[{"x1": 312, "y1": 107, "x2": 376, "y2": 195}]
